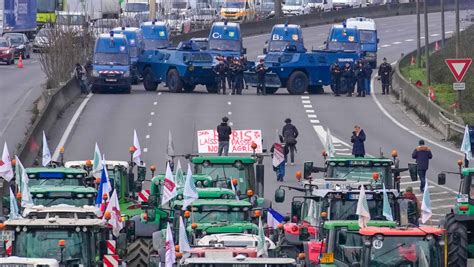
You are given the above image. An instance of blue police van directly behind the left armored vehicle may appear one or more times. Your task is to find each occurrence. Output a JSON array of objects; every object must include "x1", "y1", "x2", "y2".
[{"x1": 140, "y1": 21, "x2": 171, "y2": 50}]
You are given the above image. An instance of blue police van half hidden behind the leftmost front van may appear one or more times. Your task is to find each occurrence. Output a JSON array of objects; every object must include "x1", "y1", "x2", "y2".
[{"x1": 113, "y1": 27, "x2": 145, "y2": 84}]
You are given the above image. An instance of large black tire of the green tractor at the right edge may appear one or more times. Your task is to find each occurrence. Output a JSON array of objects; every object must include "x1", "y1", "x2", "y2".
[{"x1": 444, "y1": 213, "x2": 468, "y2": 267}]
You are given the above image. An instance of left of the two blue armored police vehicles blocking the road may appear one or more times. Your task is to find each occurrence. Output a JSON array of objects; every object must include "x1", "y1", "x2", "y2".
[{"x1": 137, "y1": 41, "x2": 217, "y2": 93}]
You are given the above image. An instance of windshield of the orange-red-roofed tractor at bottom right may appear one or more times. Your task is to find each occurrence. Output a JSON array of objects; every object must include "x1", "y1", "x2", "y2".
[{"x1": 368, "y1": 236, "x2": 441, "y2": 267}]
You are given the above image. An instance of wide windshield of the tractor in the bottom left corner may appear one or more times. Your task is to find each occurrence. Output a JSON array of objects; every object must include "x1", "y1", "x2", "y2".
[{"x1": 13, "y1": 229, "x2": 95, "y2": 266}]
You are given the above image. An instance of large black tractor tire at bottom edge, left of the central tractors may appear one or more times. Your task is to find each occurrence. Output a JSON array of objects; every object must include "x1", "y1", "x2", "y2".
[{"x1": 125, "y1": 238, "x2": 153, "y2": 267}]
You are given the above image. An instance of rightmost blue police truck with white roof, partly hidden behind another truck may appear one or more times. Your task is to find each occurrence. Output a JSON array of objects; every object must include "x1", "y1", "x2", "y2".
[{"x1": 346, "y1": 17, "x2": 379, "y2": 69}]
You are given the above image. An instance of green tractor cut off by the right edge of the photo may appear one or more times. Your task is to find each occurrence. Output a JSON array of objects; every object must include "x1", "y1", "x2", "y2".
[{"x1": 438, "y1": 164, "x2": 474, "y2": 267}]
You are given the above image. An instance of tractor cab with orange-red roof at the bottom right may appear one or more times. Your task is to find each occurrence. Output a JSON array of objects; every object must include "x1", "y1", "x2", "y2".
[{"x1": 360, "y1": 226, "x2": 444, "y2": 267}]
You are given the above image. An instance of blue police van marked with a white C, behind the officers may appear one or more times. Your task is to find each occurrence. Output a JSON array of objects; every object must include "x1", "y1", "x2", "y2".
[{"x1": 208, "y1": 21, "x2": 247, "y2": 57}]
